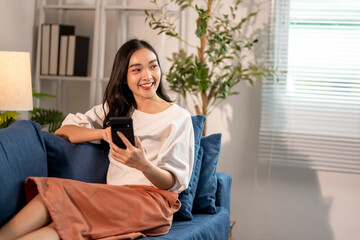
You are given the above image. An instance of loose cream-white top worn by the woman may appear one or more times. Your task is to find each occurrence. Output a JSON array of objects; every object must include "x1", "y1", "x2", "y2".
[{"x1": 62, "y1": 104, "x2": 194, "y2": 193}]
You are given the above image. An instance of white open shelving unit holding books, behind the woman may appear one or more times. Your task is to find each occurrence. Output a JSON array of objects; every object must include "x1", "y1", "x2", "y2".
[{"x1": 35, "y1": 0, "x2": 184, "y2": 112}]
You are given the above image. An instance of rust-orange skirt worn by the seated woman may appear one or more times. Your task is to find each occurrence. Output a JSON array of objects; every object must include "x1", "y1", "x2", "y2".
[{"x1": 25, "y1": 177, "x2": 180, "y2": 240}]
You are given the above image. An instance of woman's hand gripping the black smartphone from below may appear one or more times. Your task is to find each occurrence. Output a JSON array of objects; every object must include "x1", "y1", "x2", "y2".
[{"x1": 110, "y1": 132, "x2": 150, "y2": 171}]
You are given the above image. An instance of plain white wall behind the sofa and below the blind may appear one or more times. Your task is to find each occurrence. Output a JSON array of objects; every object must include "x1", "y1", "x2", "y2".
[{"x1": 0, "y1": 0, "x2": 360, "y2": 240}]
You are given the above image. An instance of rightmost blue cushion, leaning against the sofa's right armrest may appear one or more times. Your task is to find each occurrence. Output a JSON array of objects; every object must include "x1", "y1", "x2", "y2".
[{"x1": 193, "y1": 133, "x2": 221, "y2": 214}]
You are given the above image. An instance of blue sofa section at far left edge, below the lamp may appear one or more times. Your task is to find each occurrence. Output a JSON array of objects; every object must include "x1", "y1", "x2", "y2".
[{"x1": 0, "y1": 120, "x2": 47, "y2": 226}]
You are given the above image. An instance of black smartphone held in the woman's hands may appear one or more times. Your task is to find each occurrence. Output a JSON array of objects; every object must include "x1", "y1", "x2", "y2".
[{"x1": 109, "y1": 117, "x2": 135, "y2": 149}]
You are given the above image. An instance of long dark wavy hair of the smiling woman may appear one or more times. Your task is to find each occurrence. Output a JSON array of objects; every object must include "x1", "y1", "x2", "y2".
[{"x1": 103, "y1": 39, "x2": 171, "y2": 128}]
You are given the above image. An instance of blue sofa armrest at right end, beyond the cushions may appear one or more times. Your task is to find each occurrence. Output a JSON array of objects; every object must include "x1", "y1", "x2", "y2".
[{"x1": 216, "y1": 172, "x2": 232, "y2": 212}]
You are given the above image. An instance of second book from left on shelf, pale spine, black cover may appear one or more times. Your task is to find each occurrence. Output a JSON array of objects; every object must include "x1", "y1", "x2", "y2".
[{"x1": 49, "y1": 24, "x2": 75, "y2": 75}]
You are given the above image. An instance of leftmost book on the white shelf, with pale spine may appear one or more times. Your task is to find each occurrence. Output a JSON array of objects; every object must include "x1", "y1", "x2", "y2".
[{"x1": 40, "y1": 23, "x2": 50, "y2": 75}]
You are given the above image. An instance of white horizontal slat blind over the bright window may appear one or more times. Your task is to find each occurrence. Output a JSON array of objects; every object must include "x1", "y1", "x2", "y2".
[{"x1": 258, "y1": 0, "x2": 360, "y2": 174}]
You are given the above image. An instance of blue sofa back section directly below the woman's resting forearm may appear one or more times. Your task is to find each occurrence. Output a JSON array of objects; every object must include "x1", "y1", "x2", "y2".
[{"x1": 43, "y1": 132, "x2": 109, "y2": 183}]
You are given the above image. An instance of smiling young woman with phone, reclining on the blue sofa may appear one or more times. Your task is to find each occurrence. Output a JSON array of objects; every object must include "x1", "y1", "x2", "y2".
[{"x1": 0, "y1": 39, "x2": 194, "y2": 240}]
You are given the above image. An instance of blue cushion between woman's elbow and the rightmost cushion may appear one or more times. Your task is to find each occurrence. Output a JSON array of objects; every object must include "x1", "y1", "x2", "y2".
[{"x1": 174, "y1": 115, "x2": 206, "y2": 220}]
